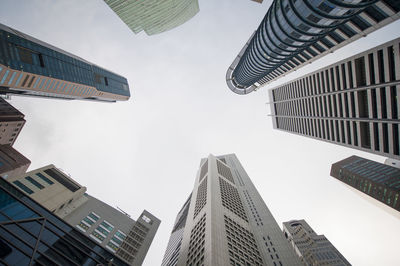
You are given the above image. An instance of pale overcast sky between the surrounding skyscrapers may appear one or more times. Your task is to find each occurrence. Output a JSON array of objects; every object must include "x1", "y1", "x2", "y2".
[{"x1": 0, "y1": 0, "x2": 400, "y2": 265}]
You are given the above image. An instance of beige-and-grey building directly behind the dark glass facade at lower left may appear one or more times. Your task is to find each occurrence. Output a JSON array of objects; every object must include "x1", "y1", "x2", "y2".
[{"x1": 8, "y1": 165, "x2": 160, "y2": 265}]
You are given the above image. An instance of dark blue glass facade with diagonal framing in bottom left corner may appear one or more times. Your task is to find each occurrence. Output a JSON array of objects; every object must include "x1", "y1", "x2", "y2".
[{"x1": 0, "y1": 178, "x2": 128, "y2": 265}]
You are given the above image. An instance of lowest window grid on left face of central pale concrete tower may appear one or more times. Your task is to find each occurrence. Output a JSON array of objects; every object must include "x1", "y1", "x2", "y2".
[{"x1": 186, "y1": 214, "x2": 206, "y2": 266}]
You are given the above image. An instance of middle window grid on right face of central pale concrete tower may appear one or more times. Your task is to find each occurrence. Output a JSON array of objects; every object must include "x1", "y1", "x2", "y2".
[{"x1": 219, "y1": 177, "x2": 248, "y2": 222}]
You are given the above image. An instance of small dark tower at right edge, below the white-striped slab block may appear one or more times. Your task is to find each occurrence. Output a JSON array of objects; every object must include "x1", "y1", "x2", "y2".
[{"x1": 331, "y1": 156, "x2": 400, "y2": 211}]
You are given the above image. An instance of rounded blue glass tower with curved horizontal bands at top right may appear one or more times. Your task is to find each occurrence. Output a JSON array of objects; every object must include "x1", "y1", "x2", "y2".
[{"x1": 226, "y1": 0, "x2": 400, "y2": 94}]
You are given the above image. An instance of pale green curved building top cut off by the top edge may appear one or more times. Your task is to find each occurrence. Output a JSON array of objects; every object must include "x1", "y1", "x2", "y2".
[{"x1": 104, "y1": 0, "x2": 199, "y2": 35}]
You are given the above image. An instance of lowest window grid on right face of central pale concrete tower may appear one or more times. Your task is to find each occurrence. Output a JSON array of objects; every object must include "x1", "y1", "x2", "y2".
[{"x1": 224, "y1": 215, "x2": 264, "y2": 266}]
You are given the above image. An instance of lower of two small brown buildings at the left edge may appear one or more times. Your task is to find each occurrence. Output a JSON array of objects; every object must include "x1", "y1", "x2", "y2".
[{"x1": 0, "y1": 145, "x2": 31, "y2": 179}]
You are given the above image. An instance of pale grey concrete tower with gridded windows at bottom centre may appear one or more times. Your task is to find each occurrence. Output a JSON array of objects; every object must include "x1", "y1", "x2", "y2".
[{"x1": 162, "y1": 154, "x2": 301, "y2": 266}]
